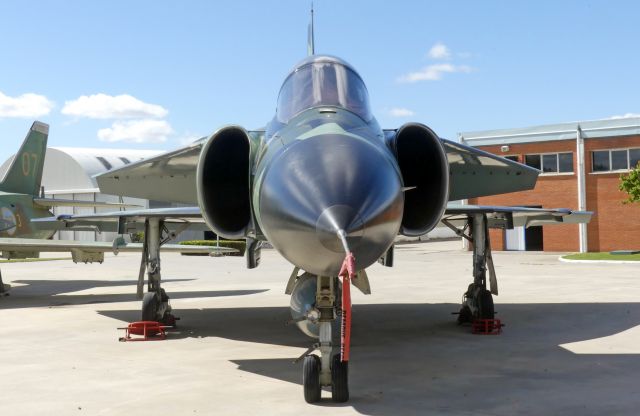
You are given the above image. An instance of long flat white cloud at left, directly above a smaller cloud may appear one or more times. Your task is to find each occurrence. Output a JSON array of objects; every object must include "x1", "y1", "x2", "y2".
[{"x1": 62, "y1": 93, "x2": 169, "y2": 119}]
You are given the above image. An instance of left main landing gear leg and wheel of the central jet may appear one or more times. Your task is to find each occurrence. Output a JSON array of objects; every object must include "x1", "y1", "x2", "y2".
[{"x1": 137, "y1": 218, "x2": 176, "y2": 326}]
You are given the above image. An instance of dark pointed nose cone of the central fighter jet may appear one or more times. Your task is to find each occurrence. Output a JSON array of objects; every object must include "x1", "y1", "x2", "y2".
[{"x1": 258, "y1": 135, "x2": 404, "y2": 276}]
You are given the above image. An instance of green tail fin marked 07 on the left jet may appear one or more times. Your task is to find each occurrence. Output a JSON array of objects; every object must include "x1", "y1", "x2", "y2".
[{"x1": 0, "y1": 121, "x2": 49, "y2": 195}]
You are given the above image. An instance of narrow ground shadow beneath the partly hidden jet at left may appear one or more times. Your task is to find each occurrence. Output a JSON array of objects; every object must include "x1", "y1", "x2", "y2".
[{"x1": 0, "y1": 279, "x2": 268, "y2": 308}]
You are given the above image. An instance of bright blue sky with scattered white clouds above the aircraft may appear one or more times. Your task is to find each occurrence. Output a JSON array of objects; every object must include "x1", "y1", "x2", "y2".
[{"x1": 0, "y1": 0, "x2": 640, "y2": 162}]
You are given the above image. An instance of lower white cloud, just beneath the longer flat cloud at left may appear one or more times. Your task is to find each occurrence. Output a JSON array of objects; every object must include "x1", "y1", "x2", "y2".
[{"x1": 98, "y1": 119, "x2": 173, "y2": 143}]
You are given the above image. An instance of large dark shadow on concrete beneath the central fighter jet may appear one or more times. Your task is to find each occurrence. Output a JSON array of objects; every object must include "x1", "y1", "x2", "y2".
[{"x1": 99, "y1": 303, "x2": 640, "y2": 415}]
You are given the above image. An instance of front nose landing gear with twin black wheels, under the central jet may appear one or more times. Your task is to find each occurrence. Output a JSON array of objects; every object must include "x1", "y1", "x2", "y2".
[{"x1": 287, "y1": 270, "x2": 350, "y2": 403}]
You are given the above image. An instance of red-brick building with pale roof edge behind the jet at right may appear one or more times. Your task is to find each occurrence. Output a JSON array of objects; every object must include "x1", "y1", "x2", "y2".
[{"x1": 460, "y1": 117, "x2": 640, "y2": 252}]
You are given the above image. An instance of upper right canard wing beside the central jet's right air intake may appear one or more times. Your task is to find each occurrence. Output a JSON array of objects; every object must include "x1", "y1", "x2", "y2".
[{"x1": 441, "y1": 139, "x2": 540, "y2": 201}]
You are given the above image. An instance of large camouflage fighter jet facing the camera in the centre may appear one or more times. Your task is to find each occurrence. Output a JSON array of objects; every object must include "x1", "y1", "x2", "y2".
[{"x1": 46, "y1": 17, "x2": 590, "y2": 403}]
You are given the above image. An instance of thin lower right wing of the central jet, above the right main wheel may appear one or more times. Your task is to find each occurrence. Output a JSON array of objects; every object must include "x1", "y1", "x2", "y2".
[{"x1": 442, "y1": 204, "x2": 593, "y2": 229}]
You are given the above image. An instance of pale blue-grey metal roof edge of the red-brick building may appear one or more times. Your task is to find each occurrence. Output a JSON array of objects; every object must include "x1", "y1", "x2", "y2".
[{"x1": 458, "y1": 117, "x2": 640, "y2": 146}]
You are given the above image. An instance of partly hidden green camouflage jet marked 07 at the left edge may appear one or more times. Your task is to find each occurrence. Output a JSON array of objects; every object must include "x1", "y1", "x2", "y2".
[{"x1": 0, "y1": 121, "x2": 233, "y2": 293}]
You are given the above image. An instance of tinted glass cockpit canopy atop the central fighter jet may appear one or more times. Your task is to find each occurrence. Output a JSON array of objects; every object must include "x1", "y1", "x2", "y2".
[{"x1": 276, "y1": 57, "x2": 372, "y2": 123}]
